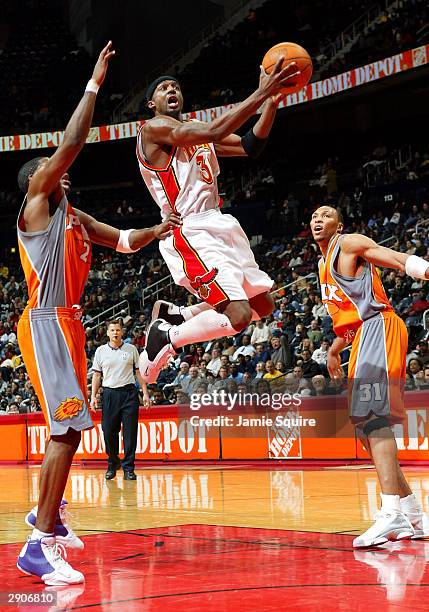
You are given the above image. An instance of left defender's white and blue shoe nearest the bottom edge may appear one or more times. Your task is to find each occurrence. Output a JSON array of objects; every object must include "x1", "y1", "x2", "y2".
[{"x1": 16, "y1": 536, "x2": 85, "y2": 586}]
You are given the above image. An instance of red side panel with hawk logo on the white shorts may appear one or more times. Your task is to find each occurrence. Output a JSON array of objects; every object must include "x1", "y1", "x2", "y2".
[{"x1": 173, "y1": 227, "x2": 229, "y2": 306}]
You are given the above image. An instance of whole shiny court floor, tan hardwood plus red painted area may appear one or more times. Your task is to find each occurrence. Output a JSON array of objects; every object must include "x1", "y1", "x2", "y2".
[{"x1": 0, "y1": 462, "x2": 429, "y2": 612}]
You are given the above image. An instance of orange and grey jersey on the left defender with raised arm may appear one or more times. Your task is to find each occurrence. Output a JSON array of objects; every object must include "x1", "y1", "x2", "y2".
[{"x1": 18, "y1": 196, "x2": 91, "y2": 308}]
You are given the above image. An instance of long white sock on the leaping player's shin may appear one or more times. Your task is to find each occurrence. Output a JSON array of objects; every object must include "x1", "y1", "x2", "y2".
[{"x1": 170, "y1": 308, "x2": 238, "y2": 348}]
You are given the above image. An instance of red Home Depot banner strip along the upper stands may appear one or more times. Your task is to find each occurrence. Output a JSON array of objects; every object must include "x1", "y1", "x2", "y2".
[{"x1": 0, "y1": 45, "x2": 429, "y2": 153}]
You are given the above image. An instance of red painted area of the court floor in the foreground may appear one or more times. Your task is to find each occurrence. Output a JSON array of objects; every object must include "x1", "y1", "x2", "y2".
[{"x1": 0, "y1": 525, "x2": 429, "y2": 612}]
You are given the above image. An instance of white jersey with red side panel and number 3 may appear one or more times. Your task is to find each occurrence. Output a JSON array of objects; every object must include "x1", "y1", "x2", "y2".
[{"x1": 136, "y1": 122, "x2": 219, "y2": 219}]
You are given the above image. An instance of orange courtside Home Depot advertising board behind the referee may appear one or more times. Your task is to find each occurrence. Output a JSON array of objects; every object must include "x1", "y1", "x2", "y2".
[{"x1": 0, "y1": 392, "x2": 429, "y2": 461}]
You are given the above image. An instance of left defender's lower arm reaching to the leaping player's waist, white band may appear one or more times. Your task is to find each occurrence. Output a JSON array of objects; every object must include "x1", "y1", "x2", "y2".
[{"x1": 76, "y1": 210, "x2": 182, "y2": 253}]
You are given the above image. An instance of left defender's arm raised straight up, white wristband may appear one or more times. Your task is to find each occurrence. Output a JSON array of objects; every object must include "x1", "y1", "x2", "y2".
[{"x1": 28, "y1": 41, "x2": 115, "y2": 201}]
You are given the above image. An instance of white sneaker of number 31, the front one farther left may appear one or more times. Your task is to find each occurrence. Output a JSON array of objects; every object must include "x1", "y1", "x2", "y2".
[{"x1": 353, "y1": 510, "x2": 414, "y2": 548}]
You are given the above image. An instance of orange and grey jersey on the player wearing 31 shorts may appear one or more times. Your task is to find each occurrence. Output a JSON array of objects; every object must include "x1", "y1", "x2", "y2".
[{"x1": 319, "y1": 234, "x2": 393, "y2": 342}]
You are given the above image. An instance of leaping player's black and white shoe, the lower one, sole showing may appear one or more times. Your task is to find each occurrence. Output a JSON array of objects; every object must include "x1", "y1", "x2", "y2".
[{"x1": 139, "y1": 319, "x2": 177, "y2": 385}]
